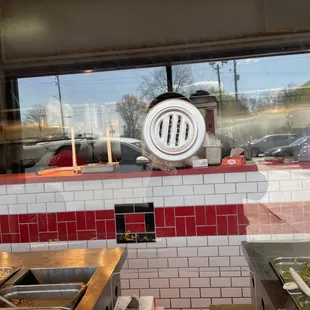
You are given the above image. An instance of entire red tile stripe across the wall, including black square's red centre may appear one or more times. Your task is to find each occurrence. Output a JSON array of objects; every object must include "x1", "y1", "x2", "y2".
[{"x1": 0, "y1": 202, "x2": 310, "y2": 243}]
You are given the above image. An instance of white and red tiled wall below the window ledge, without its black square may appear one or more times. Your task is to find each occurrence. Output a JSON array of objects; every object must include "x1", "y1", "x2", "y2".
[{"x1": 0, "y1": 169, "x2": 310, "y2": 309}]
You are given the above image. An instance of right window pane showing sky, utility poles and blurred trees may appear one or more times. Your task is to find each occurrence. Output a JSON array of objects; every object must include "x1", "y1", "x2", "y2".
[{"x1": 173, "y1": 54, "x2": 310, "y2": 152}]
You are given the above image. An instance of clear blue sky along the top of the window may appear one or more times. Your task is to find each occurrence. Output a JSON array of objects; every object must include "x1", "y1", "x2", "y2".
[{"x1": 19, "y1": 54, "x2": 310, "y2": 114}]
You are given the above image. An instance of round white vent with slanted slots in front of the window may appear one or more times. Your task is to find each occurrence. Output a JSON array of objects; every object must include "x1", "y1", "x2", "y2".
[{"x1": 143, "y1": 99, "x2": 206, "y2": 161}]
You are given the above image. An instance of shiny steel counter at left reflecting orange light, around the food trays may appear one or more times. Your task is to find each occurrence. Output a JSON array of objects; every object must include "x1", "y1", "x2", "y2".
[{"x1": 0, "y1": 248, "x2": 127, "y2": 310}]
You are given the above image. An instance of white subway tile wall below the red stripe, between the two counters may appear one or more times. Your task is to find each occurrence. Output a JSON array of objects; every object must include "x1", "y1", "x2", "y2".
[{"x1": 121, "y1": 236, "x2": 250, "y2": 310}]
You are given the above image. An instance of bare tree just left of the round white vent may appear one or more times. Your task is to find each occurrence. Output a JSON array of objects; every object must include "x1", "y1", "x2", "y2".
[{"x1": 116, "y1": 94, "x2": 146, "y2": 138}]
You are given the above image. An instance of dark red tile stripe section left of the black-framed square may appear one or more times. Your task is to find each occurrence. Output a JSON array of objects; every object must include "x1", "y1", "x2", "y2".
[{"x1": 0, "y1": 210, "x2": 115, "y2": 243}]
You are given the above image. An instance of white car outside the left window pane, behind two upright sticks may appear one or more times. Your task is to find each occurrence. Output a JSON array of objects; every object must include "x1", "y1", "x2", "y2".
[{"x1": 14, "y1": 138, "x2": 143, "y2": 172}]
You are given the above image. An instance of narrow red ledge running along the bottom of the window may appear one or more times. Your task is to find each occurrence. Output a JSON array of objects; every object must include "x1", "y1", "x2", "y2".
[{"x1": 0, "y1": 162, "x2": 310, "y2": 185}]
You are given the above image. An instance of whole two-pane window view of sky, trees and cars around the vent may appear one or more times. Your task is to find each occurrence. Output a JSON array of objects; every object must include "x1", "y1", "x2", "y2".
[{"x1": 1, "y1": 54, "x2": 310, "y2": 173}]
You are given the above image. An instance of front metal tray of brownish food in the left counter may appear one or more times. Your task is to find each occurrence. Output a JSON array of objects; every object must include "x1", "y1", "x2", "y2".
[{"x1": 0, "y1": 283, "x2": 87, "y2": 309}]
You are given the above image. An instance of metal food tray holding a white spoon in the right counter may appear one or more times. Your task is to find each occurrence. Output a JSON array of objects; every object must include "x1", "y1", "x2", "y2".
[{"x1": 270, "y1": 257, "x2": 310, "y2": 310}]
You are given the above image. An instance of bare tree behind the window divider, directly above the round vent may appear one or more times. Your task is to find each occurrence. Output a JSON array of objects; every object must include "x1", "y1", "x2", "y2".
[{"x1": 139, "y1": 65, "x2": 193, "y2": 101}]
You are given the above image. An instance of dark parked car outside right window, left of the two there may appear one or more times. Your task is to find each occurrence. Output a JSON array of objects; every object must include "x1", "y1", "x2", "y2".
[{"x1": 251, "y1": 134, "x2": 297, "y2": 157}]
